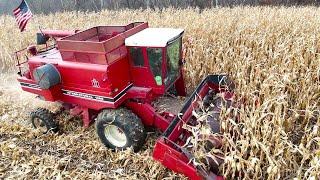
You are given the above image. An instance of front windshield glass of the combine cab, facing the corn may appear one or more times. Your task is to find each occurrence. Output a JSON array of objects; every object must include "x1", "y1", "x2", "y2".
[{"x1": 164, "y1": 37, "x2": 181, "y2": 86}]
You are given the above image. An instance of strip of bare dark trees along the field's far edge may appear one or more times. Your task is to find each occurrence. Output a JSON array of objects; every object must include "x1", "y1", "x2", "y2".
[{"x1": 0, "y1": 0, "x2": 320, "y2": 14}]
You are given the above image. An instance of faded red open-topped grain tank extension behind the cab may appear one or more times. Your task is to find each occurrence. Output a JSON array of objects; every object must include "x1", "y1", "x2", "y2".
[{"x1": 57, "y1": 23, "x2": 148, "y2": 64}]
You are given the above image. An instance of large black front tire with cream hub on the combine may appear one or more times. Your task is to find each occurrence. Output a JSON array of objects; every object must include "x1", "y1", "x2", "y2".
[{"x1": 96, "y1": 108, "x2": 147, "y2": 152}]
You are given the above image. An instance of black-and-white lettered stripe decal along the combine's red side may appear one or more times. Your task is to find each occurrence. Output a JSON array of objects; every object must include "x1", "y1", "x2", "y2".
[{"x1": 62, "y1": 84, "x2": 132, "y2": 102}]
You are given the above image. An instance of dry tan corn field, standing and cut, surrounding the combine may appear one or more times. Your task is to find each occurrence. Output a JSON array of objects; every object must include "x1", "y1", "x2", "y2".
[{"x1": 0, "y1": 7, "x2": 320, "y2": 179}]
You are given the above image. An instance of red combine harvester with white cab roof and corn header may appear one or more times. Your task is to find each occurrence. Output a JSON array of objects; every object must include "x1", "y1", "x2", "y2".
[{"x1": 16, "y1": 22, "x2": 233, "y2": 179}]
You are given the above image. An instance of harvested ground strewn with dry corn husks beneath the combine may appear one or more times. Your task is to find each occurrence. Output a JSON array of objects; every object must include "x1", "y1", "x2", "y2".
[{"x1": 0, "y1": 74, "x2": 184, "y2": 179}]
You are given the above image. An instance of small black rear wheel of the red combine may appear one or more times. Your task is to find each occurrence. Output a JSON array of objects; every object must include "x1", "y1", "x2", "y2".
[{"x1": 30, "y1": 108, "x2": 59, "y2": 134}]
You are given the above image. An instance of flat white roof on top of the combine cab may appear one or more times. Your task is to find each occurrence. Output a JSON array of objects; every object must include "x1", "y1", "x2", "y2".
[{"x1": 125, "y1": 28, "x2": 184, "y2": 47}]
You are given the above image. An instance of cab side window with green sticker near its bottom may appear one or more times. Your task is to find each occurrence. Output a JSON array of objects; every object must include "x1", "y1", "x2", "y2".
[{"x1": 147, "y1": 48, "x2": 162, "y2": 86}]
